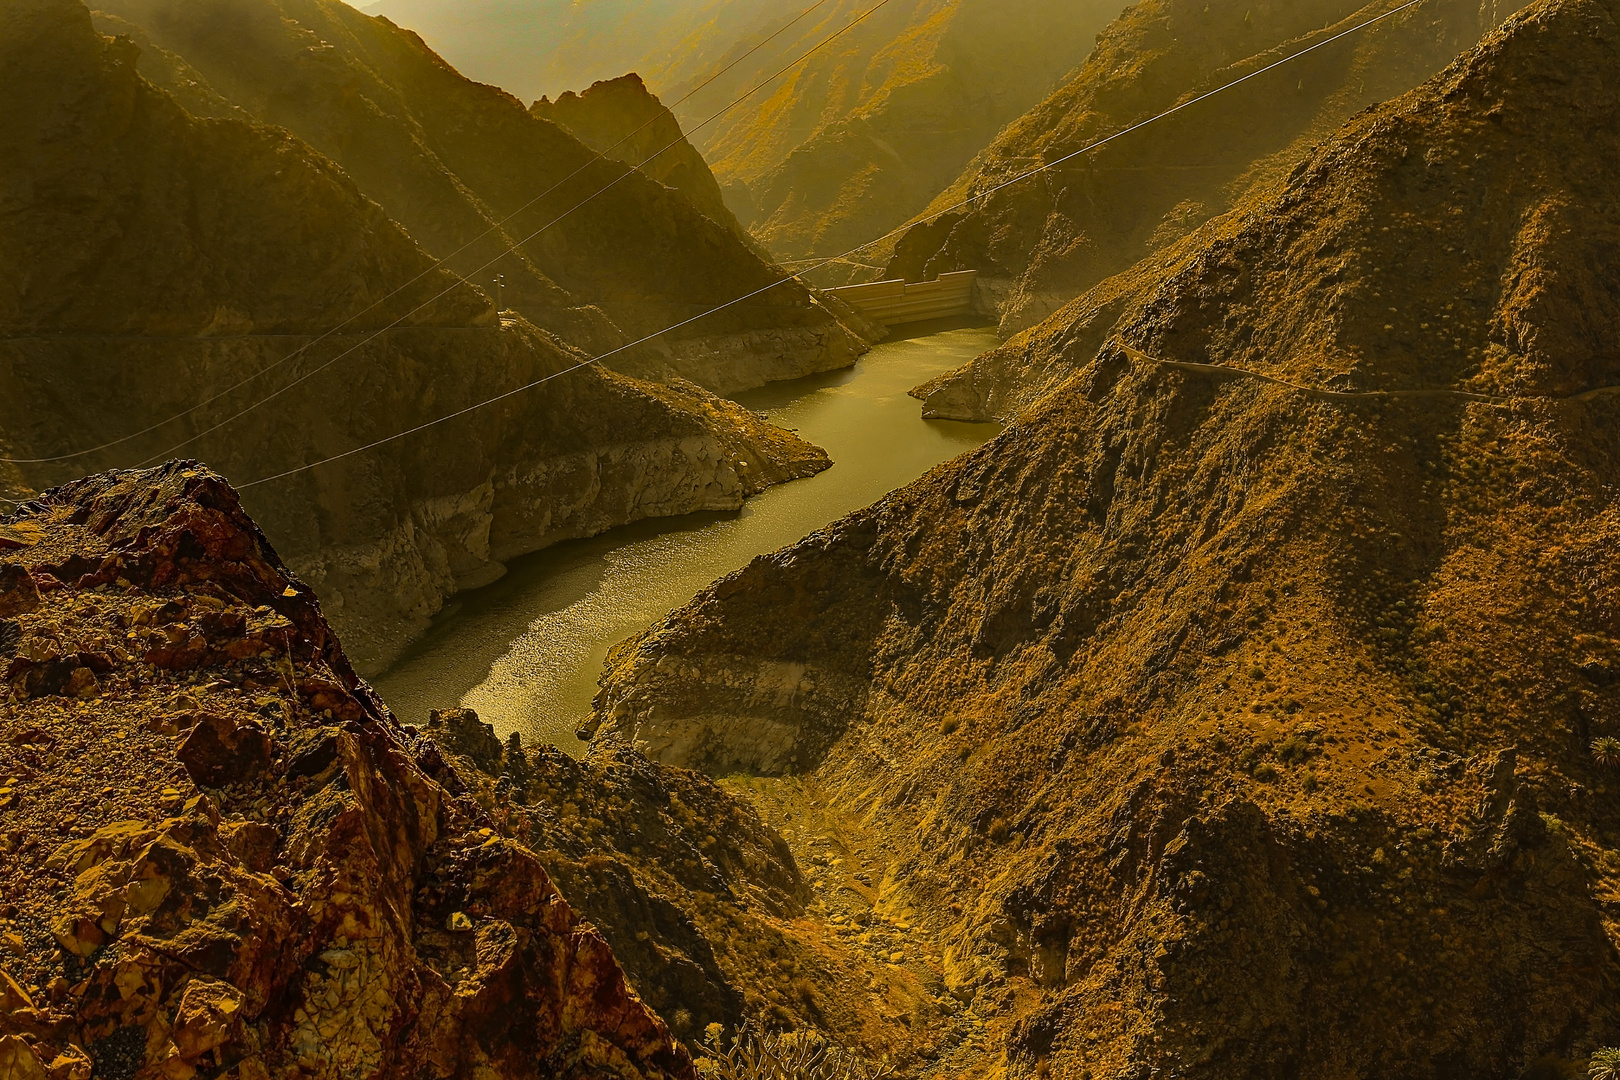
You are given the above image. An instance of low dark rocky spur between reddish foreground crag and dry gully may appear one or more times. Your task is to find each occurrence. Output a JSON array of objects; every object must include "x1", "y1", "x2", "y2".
[{"x1": 423, "y1": 709, "x2": 969, "y2": 1075}]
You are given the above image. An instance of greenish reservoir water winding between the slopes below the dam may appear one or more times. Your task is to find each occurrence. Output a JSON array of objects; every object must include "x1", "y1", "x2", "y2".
[{"x1": 373, "y1": 327, "x2": 1000, "y2": 755}]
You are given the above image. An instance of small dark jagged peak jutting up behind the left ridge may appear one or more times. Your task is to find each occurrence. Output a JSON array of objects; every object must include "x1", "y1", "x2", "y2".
[{"x1": 528, "y1": 74, "x2": 744, "y2": 242}]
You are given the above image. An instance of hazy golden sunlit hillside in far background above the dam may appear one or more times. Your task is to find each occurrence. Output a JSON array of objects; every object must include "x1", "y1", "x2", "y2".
[{"x1": 643, "y1": 0, "x2": 1119, "y2": 272}]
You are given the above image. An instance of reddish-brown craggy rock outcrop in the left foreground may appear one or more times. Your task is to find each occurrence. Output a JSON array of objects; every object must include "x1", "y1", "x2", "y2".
[{"x1": 0, "y1": 463, "x2": 695, "y2": 1080}]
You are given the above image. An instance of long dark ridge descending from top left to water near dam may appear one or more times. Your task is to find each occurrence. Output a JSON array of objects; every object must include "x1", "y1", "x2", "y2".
[{"x1": 99, "y1": 0, "x2": 865, "y2": 390}]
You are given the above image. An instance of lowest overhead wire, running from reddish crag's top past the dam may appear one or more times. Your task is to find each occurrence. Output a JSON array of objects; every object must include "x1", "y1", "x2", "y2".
[{"x1": 237, "y1": 0, "x2": 1424, "y2": 491}]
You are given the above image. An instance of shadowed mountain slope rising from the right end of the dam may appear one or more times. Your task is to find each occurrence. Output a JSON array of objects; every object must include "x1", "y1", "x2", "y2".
[{"x1": 888, "y1": 0, "x2": 1518, "y2": 334}]
